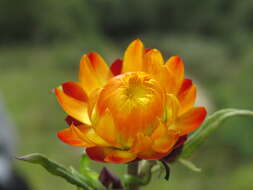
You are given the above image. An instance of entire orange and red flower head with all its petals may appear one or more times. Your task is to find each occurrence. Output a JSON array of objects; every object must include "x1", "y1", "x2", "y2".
[{"x1": 55, "y1": 40, "x2": 206, "y2": 163}]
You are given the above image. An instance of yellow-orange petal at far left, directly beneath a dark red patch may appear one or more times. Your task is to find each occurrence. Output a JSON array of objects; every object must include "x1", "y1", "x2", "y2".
[{"x1": 55, "y1": 88, "x2": 90, "y2": 125}]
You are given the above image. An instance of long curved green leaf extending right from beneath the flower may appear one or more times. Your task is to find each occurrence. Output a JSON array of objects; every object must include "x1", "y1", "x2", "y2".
[{"x1": 180, "y1": 109, "x2": 253, "y2": 158}]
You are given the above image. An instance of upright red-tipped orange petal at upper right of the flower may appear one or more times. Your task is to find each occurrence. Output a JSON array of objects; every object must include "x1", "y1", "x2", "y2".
[{"x1": 165, "y1": 56, "x2": 184, "y2": 94}]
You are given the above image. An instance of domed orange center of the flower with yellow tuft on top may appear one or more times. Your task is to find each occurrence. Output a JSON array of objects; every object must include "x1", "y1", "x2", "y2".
[{"x1": 98, "y1": 72, "x2": 164, "y2": 135}]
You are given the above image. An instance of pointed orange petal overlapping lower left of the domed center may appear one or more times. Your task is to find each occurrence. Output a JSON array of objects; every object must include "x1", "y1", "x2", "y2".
[{"x1": 94, "y1": 109, "x2": 120, "y2": 147}]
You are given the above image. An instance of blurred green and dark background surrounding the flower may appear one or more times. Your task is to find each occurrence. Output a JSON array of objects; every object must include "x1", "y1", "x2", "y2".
[{"x1": 0, "y1": 0, "x2": 253, "y2": 190}]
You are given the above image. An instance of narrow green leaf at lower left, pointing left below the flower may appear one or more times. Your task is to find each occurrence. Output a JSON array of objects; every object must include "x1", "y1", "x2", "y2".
[{"x1": 17, "y1": 153, "x2": 105, "y2": 190}]
